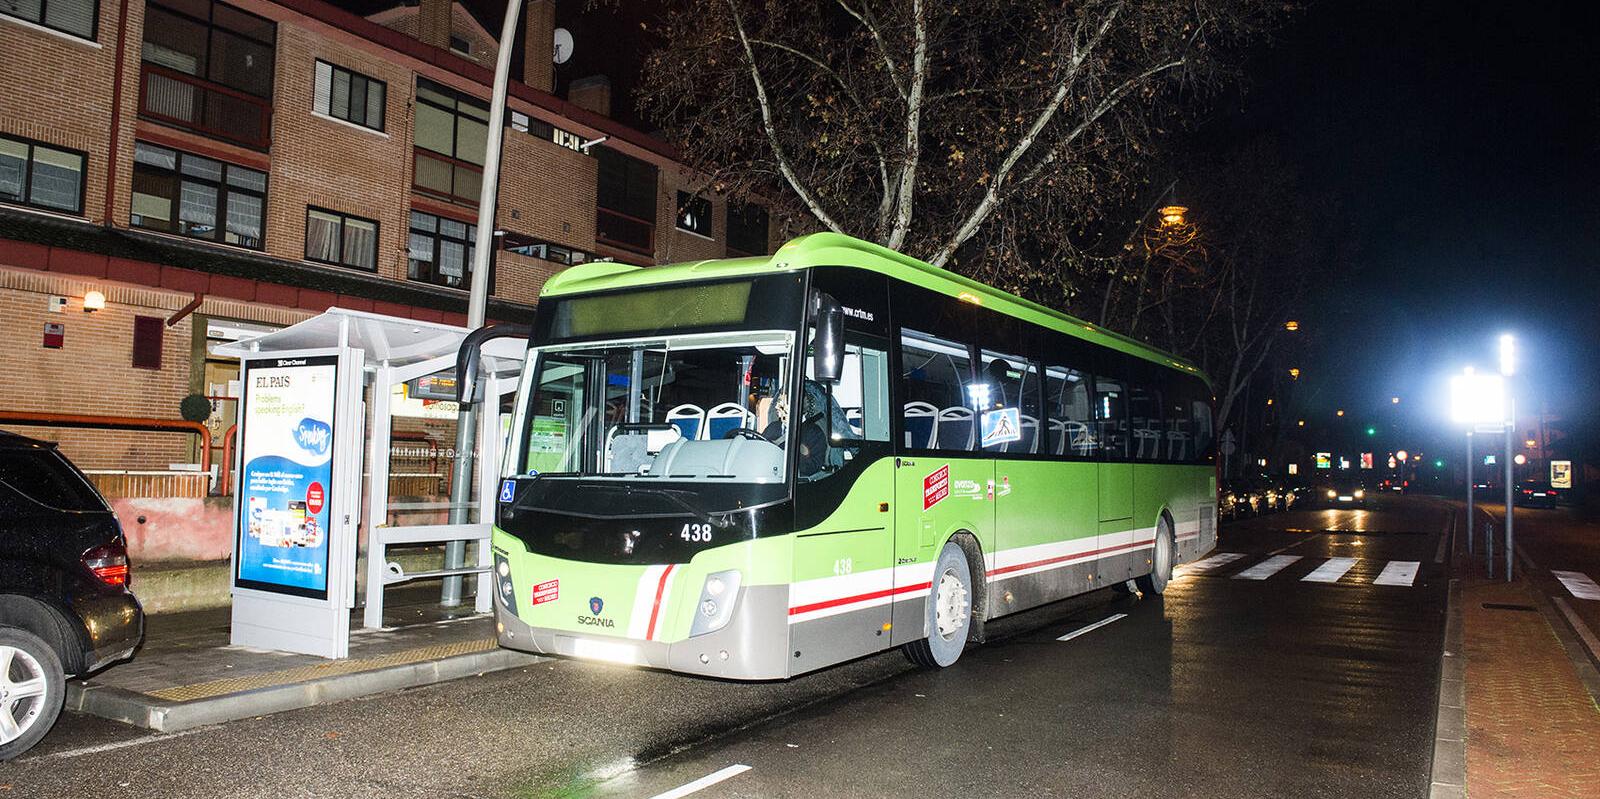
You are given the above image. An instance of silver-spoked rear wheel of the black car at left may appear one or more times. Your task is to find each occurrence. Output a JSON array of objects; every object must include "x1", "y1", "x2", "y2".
[{"x1": 0, "y1": 628, "x2": 67, "y2": 761}]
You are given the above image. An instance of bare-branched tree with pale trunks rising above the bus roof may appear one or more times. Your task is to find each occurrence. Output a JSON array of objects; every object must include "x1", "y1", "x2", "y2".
[{"x1": 642, "y1": 0, "x2": 1283, "y2": 273}]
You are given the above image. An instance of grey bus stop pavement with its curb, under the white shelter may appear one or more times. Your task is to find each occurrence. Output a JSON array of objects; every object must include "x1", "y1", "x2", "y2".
[{"x1": 67, "y1": 584, "x2": 538, "y2": 732}]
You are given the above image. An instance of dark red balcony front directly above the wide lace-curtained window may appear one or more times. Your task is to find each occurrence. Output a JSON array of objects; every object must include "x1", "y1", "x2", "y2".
[{"x1": 139, "y1": 62, "x2": 272, "y2": 151}]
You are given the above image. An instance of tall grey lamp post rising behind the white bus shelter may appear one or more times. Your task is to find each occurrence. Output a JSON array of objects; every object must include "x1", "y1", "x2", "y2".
[{"x1": 440, "y1": 0, "x2": 522, "y2": 607}]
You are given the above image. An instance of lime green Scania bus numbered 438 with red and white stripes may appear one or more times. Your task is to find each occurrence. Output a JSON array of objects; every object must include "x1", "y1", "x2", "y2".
[{"x1": 493, "y1": 234, "x2": 1216, "y2": 679}]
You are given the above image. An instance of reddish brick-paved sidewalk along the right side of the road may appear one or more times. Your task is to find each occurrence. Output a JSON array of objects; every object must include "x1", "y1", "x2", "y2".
[{"x1": 1453, "y1": 514, "x2": 1600, "y2": 799}]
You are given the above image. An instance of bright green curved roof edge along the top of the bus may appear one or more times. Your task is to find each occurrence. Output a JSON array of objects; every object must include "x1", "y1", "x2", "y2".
[{"x1": 539, "y1": 232, "x2": 1211, "y2": 384}]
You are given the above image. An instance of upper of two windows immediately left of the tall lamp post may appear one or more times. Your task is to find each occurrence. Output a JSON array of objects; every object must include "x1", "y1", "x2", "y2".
[{"x1": 411, "y1": 78, "x2": 490, "y2": 205}]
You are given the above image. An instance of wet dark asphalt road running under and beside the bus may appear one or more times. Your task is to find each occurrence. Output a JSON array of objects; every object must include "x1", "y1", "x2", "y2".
[{"x1": 0, "y1": 498, "x2": 1450, "y2": 799}]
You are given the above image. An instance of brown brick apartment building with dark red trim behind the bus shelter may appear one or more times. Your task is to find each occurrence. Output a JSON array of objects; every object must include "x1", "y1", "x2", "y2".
[{"x1": 0, "y1": 0, "x2": 776, "y2": 469}]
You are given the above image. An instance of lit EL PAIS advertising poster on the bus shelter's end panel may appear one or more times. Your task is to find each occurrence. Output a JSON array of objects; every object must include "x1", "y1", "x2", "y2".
[{"x1": 235, "y1": 355, "x2": 338, "y2": 599}]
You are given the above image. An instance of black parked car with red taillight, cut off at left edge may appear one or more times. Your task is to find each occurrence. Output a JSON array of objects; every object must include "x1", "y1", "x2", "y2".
[{"x1": 0, "y1": 432, "x2": 144, "y2": 761}]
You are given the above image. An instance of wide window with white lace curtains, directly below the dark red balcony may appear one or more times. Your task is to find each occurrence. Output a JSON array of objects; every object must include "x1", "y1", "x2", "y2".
[{"x1": 130, "y1": 141, "x2": 267, "y2": 250}]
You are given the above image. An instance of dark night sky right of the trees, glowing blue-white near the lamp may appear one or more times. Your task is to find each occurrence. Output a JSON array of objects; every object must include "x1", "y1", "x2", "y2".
[{"x1": 1218, "y1": 0, "x2": 1600, "y2": 448}]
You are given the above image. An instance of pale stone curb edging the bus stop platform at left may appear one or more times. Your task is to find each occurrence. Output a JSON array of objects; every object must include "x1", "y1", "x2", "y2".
[{"x1": 66, "y1": 648, "x2": 546, "y2": 732}]
